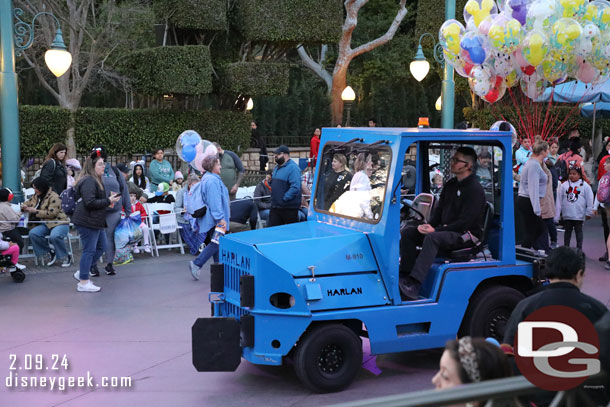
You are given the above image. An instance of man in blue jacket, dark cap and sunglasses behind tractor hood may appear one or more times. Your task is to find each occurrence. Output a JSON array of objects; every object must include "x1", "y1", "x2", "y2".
[{"x1": 267, "y1": 146, "x2": 301, "y2": 226}]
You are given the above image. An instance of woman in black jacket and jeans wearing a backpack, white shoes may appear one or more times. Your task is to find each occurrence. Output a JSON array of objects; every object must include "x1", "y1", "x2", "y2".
[{"x1": 72, "y1": 154, "x2": 120, "y2": 293}]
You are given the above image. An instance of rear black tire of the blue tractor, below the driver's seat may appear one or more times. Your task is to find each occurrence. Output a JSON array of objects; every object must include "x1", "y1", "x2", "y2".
[{"x1": 458, "y1": 286, "x2": 525, "y2": 343}]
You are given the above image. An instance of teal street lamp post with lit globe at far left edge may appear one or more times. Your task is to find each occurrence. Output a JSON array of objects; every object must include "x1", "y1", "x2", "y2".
[{"x1": 0, "y1": 0, "x2": 72, "y2": 202}]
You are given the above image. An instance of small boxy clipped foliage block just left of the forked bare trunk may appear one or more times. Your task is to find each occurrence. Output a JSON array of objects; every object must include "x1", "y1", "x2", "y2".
[{"x1": 226, "y1": 62, "x2": 289, "y2": 96}]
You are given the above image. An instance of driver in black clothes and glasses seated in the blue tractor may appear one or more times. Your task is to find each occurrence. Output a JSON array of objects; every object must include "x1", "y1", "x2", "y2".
[{"x1": 399, "y1": 147, "x2": 485, "y2": 300}]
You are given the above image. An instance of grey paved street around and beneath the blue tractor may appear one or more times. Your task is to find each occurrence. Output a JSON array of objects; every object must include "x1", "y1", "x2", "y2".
[{"x1": 0, "y1": 218, "x2": 610, "y2": 407}]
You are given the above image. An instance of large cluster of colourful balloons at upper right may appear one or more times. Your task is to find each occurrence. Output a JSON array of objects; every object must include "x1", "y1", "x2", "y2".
[{"x1": 439, "y1": 0, "x2": 610, "y2": 103}]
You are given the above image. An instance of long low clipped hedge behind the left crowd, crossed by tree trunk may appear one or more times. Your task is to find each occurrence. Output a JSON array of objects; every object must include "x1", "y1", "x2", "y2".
[{"x1": 19, "y1": 106, "x2": 252, "y2": 157}]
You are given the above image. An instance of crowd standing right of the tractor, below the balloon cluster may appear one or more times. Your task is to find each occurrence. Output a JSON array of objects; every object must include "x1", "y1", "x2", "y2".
[{"x1": 513, "y1": 129, "x2": 610, "y2": 258}]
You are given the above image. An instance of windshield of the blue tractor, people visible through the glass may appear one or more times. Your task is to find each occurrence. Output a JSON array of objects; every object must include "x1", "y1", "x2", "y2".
[{"x1": 314, "y1": 143, "x2": 392, "y2": 223}]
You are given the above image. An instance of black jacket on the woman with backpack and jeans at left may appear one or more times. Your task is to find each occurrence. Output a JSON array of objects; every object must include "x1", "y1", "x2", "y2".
[{"x1": 72, "y1": 176, "x2": 110, "y2": 229}]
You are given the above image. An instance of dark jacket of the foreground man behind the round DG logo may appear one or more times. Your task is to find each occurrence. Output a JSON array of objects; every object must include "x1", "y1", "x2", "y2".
[{"x1": 504, "y1": 282, "x2": 608, "y2": 345}]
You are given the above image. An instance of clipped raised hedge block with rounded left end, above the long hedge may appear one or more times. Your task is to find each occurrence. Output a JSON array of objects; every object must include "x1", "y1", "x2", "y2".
[{"x1": 119, "y1": 45, "x2": 212, "y2": 95}]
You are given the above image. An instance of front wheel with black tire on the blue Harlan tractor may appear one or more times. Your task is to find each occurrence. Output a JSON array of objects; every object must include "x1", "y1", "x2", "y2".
[{"x1": 294, "y1": 324, "x2": 362, "y2": 393}]
